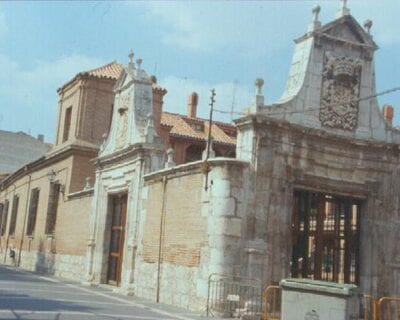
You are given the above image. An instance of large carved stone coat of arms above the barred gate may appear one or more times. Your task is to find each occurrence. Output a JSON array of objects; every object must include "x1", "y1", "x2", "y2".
[{"x1": 319, "y1": 55, "x2": 361, "y2": 130}]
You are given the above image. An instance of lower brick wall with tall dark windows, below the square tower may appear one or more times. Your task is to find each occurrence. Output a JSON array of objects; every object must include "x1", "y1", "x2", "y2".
[{"x1": 0, "y1": 152, "x2": 93, "y2": 274}]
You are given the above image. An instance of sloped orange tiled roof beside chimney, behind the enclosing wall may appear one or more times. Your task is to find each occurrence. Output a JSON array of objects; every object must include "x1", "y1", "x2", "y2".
[{"x1": 161, "y1": 112, "x2": 236, "y2": 145}]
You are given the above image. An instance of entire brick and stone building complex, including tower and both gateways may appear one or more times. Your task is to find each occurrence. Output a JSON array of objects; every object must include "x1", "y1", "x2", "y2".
[{"x1": 0, "y1": 1, "x2": 400, "y2": 311}]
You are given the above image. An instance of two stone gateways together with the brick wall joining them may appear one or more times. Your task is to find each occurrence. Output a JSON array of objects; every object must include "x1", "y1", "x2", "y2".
[{"x1": 82, "y1": 2, "x2": 400, "y2": 311}]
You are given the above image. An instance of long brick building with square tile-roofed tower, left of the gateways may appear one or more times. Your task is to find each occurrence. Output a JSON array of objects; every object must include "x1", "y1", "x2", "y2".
[{"x1": 0, "y1": 63, "x2": 119, "y2": 279}]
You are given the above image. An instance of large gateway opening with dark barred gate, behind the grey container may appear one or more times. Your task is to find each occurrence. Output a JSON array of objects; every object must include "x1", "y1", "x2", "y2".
[{"x1": 291, "y1": 191, "x2": 360, "y2": 284}]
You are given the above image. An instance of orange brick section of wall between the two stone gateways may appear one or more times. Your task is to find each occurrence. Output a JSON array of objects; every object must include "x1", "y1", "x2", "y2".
[{"x1": 143, "y1": 174, "x2": 208, "y2": 267}]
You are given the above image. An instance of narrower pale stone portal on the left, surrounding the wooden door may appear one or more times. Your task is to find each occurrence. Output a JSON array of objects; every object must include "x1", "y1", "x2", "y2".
[{"x1": 86, "y1": 61, "x2": 164, "y2": 292}]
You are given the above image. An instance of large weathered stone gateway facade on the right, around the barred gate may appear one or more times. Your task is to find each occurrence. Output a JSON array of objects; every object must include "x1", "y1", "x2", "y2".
[{"x1": 236, "y1": 6, "x2": 400, "y2": 296}]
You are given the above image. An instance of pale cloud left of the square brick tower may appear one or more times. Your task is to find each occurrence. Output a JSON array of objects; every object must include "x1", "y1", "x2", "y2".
[{"x1": 0, "y1": 54, "x2": 104, "y2": 141}]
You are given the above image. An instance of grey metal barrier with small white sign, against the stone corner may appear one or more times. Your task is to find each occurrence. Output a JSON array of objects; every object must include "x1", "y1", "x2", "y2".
[{"x1": 207, "y1": 273, "x2": 262, "y2": 318}]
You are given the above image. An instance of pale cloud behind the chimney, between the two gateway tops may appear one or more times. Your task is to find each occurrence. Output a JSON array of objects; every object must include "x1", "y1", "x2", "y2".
[{"x1": 160, "y1": 76, "x2": 253, "y2": 122}]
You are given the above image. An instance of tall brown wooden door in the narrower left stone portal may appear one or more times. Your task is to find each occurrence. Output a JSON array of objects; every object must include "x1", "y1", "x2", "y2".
[{"x1": 107, "y1": 194, "x2": 127, "y2": 286}]
